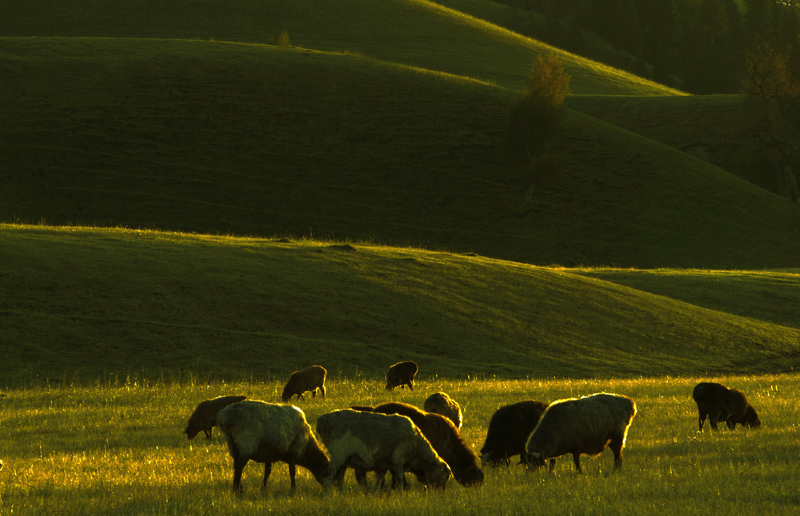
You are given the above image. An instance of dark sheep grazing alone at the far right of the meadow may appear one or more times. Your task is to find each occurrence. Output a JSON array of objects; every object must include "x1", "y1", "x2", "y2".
[{"x1": 692, "y1": 382, "x2": 761, "y2": 432}]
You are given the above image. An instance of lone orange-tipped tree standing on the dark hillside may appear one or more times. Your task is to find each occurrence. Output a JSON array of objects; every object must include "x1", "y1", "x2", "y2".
[{"x1": 506, "y1": 54, "x2": 570, "y2": 203}]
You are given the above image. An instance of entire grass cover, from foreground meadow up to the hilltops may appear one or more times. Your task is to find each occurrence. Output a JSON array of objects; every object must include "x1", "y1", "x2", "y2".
[{"x1": 0, "y1": 0, "x2": 800, "y2": 515}]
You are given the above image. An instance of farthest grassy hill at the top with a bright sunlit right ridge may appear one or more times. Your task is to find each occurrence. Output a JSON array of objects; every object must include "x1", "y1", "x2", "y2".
[{"x1": 0, "y1": 0, "x2": 677, "y2": 95}]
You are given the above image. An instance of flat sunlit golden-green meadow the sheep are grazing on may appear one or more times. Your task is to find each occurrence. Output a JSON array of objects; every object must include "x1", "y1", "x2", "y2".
[{"x1": 0, "y1": 374, "x2": 800, "y2": 515}]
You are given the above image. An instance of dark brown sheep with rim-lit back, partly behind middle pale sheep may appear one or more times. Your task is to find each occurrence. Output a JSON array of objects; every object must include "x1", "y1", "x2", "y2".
[{"x1": 355, "y1": 402, "x2": 483, "y2": 487}]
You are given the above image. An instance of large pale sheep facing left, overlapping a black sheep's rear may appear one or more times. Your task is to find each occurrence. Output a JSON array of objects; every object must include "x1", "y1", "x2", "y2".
[{"x1": 526, "y1": 393, "x2": 636, "y2": 473}]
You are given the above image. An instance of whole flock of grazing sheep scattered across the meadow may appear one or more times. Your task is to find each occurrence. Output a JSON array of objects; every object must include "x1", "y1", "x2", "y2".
[{"x1": 184, "y1": 361, "x2": 761, "y2": 494}]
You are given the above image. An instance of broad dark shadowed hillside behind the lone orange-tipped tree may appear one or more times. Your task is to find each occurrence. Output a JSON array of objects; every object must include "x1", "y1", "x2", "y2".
[{"x1": 0, "y1": 38, "x2": 800, "y2": 268}]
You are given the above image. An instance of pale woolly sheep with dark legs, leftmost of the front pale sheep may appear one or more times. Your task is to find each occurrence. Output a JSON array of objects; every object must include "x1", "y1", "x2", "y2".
[{"x1": 217, "y1": 400, "x2": 328, "y2": 494}]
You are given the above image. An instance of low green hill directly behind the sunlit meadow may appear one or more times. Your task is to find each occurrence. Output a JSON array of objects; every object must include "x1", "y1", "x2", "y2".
[{"x1": 0, "y1": 226, "x2": 800, "y2": 383}]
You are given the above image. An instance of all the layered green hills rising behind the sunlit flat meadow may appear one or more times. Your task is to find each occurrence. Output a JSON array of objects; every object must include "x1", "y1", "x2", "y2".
[{"x1": 0, "y1": 0, "x2": 800, "y2": 384}]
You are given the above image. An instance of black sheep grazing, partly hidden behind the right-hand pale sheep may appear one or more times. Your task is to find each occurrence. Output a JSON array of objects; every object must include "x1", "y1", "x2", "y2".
[{"x1": 481, "y1": 401, "x2": 547, "y2": 466}]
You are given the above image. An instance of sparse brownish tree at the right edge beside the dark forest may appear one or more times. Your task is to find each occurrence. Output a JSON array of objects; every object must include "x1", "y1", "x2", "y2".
[{"x1": 742, "y1": 40, "x2": 800, "y2": 202}]
